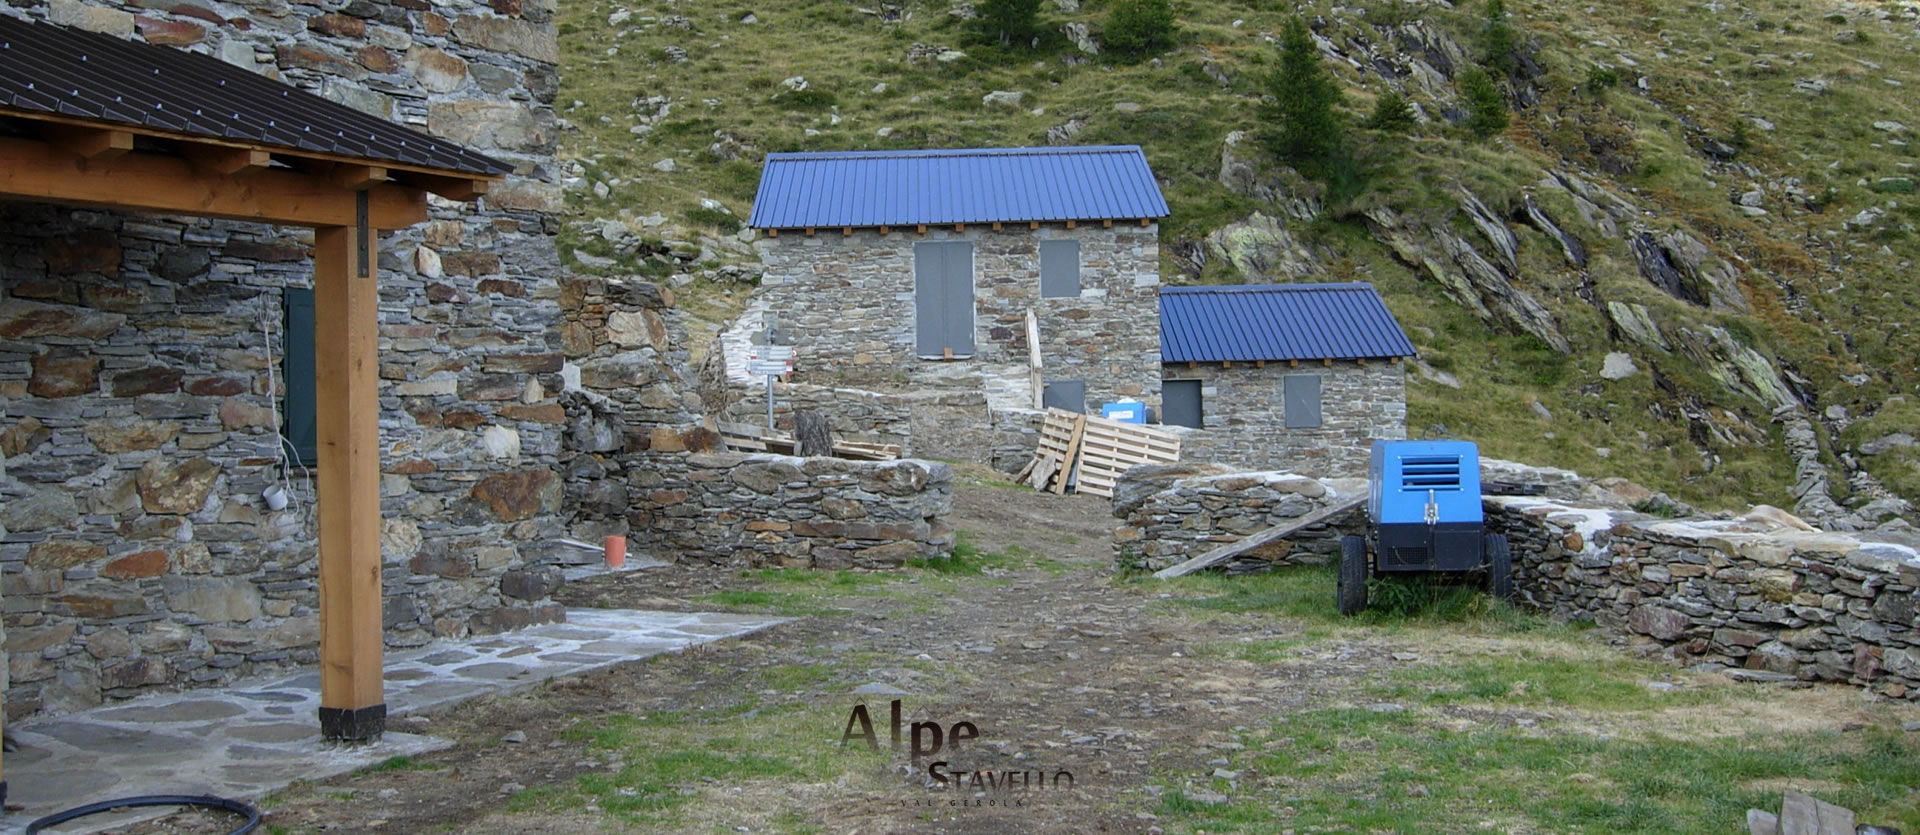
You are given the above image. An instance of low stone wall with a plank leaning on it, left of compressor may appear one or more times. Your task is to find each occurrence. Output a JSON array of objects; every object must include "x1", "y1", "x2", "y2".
[{"x1": 1114, "y1": 465, "x2": 1367, "y2": 572}]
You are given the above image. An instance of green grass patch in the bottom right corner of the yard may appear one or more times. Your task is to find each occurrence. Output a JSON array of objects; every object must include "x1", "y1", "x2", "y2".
[{"x1": 1158, "y1": 708, "x2": 1920, "y2": 833}]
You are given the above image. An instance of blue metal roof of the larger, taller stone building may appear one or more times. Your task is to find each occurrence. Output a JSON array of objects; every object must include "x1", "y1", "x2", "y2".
[{"x1": 747, "y1": 146, "x2": 1167, "y2": 228}]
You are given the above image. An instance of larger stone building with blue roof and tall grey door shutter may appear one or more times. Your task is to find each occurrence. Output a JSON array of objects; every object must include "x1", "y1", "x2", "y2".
[{"x1": 745, "y1": 146, "x2": 1167, "y2": 418}]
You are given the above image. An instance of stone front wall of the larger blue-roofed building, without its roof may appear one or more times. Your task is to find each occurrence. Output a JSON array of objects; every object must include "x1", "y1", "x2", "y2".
[{"x1": 756, "y1": 225, "x2": 1160, "y2": 409}]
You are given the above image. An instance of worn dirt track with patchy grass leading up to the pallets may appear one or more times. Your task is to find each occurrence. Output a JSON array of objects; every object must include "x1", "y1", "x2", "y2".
[{"x1": 142, "y1": 476, "x2": 1920, "y2": 833}]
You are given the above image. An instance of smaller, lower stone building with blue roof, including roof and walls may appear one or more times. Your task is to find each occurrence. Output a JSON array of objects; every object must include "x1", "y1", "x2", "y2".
[{"x1": 1160, "y1": 284, "x2": 1413, "y2": 478}]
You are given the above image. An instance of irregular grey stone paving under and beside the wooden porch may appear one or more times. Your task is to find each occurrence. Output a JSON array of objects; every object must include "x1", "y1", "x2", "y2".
[{"x1": 0, "y1": 608, "x2": 789, "y2": 835}]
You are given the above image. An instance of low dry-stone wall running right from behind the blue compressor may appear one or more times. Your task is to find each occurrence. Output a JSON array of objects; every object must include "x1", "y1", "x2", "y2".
[{"x1": 1486, "y1": 497, "x2": 1920, "y2": 699}]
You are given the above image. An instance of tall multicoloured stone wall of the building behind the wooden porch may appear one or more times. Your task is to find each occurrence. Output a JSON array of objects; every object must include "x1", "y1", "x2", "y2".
[{"x1": 0, "y1": 0, "x2": 564, "y2": 716}]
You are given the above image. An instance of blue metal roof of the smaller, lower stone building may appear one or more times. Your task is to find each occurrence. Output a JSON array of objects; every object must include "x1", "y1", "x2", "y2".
[{"x1": 1160, "y1": 282, "x2": 1413, "y2": 363}]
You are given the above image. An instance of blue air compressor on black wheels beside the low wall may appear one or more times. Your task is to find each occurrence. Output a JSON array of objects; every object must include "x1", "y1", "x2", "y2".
[{"x1": 1338, "y1": 441, "x2": 1513, "y2": 614}]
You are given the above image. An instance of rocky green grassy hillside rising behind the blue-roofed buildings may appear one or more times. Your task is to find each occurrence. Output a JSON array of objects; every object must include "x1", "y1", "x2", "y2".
[{"x1": 559, "y1": 0, "x2": 1920, "y2": 509}]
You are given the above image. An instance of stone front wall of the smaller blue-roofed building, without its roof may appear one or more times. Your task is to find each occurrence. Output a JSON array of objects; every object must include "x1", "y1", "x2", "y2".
[{"x1": 1164, "y1": 361, "x2": 1407, "y2": 478}]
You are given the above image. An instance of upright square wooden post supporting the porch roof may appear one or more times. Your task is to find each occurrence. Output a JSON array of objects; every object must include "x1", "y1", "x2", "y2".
[{"x1": 313, "y1": 227, "x2": 386, "y2": 741}]
